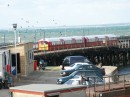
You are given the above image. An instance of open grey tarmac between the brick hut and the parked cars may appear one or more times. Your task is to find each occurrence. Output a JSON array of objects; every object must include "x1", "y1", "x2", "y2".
[{"x1": 14, "y1": 67, "x2": 60, "y2": 86}]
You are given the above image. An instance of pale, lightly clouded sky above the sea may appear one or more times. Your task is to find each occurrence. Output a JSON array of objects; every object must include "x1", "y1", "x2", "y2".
[{"x1": 0, "y1": 0, "x2": 130, "y2": 29}]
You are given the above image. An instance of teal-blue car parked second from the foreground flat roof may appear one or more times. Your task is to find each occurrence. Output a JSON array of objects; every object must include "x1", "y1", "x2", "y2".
[{"x1": 57, "y1": 70, "x2": 103, "y2": 84}]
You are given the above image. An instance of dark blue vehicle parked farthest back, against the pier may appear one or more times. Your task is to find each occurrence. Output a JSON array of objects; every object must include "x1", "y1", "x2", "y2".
[{"x1": 62, "y1": 56, "x2": 91, "y2": 70}]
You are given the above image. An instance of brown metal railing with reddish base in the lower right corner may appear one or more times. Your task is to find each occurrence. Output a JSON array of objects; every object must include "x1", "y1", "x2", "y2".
[{"x1": 86, "y1": 73, "x2": 130, "y2": 97}]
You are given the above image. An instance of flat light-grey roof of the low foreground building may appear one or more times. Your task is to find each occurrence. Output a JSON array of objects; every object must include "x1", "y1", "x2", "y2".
[{"x1": 10, "y1": 84, "x2": 86, "y2": 92}]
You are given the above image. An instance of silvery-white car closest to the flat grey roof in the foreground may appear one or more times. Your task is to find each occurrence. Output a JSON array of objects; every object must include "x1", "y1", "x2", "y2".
[{"x1": 64, "y1": 75, "x2": 105, "y2": 87}]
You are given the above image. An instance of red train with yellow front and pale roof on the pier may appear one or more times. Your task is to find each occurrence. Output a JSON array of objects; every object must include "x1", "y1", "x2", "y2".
[{"x1": 38, "y1": 34, "x2": 119, "y2": 51}]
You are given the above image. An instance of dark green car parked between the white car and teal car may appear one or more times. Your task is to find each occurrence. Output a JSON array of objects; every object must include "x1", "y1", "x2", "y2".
[{"x1": 60, "y1": 62, "x2": 105, "y2": 76}]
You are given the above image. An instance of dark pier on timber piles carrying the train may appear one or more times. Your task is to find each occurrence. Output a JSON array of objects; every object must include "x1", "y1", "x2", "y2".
[{"x1": 34, "y1": 36, "x2": 130, "y2": 66}]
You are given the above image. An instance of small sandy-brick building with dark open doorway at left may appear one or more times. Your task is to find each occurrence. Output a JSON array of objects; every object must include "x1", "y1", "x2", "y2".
[{"x1": 0, "y1": 42, "x2": 34, "y2": 76}]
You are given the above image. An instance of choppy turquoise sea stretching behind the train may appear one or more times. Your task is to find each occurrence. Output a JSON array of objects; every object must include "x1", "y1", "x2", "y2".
[{"x1": 0, "y1": 23, "x2": 130, "y2": 43}]
